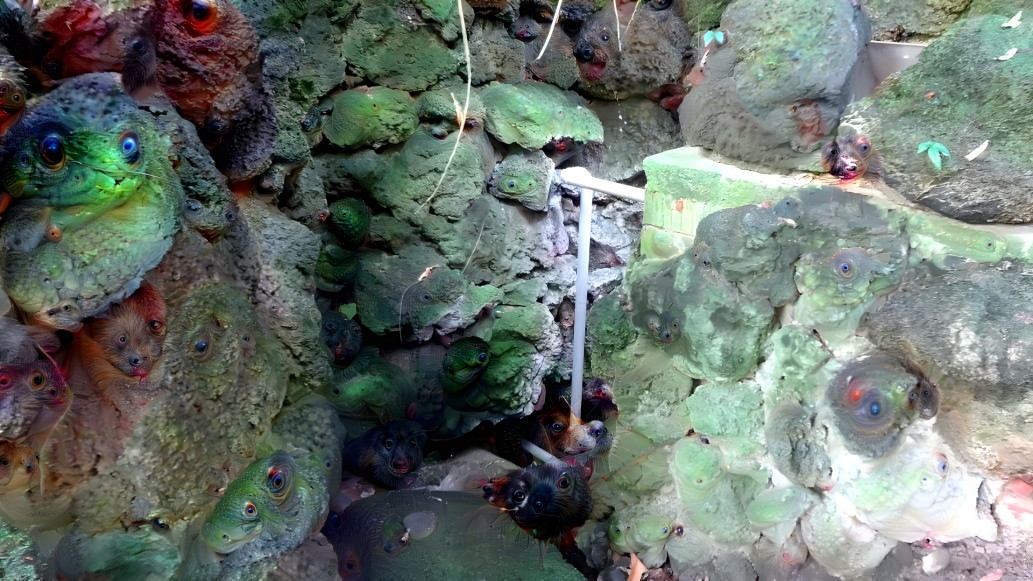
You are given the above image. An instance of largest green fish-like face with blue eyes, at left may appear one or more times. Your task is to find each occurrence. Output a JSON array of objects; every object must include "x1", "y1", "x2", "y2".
[{"x1": 0, "y1": 73, "x2": 183, "y2": 320}]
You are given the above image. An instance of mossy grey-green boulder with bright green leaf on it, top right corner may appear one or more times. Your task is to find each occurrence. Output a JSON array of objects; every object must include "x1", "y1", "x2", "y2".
[{"x1": 844, "y1": 11, "x2": 1033, "y2": 222}]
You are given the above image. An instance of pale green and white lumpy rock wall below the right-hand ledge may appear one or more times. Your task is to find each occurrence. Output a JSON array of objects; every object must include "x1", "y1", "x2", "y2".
[{"x1": 589, "y1": 187, "x2": 1033, "y2": 579}]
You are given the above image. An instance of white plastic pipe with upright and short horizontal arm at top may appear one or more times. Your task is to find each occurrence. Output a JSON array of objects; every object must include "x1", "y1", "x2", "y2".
[{"x1": 559, "y1": 167, "x2": 646, "y2": 418}]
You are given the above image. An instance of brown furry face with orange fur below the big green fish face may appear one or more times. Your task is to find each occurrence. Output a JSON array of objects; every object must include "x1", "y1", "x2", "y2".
[{"x1": 94, "y1": 305, "x2": 165, "y2": 377}]
